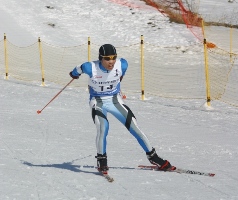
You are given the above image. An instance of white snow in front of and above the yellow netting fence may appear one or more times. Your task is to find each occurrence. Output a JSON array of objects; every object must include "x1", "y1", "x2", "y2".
[{"x1": 0, "y1": 0, "x2": 238, "y2": 200}]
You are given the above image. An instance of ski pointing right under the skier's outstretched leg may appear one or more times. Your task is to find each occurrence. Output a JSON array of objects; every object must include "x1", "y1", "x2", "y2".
[{"x1": 138, "y1": 165, "x2": 215, "y2": 177}]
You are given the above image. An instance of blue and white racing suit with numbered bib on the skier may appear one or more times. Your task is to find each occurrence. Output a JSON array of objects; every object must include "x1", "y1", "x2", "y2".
[{"x1": 72, "y1": 58, "x2": 152, "y2": 154}]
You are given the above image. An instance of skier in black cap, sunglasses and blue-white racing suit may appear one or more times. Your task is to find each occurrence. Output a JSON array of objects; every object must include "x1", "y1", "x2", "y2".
[{"x1": 69, "y1": 44, "x2": 175, "y2": 172}]
